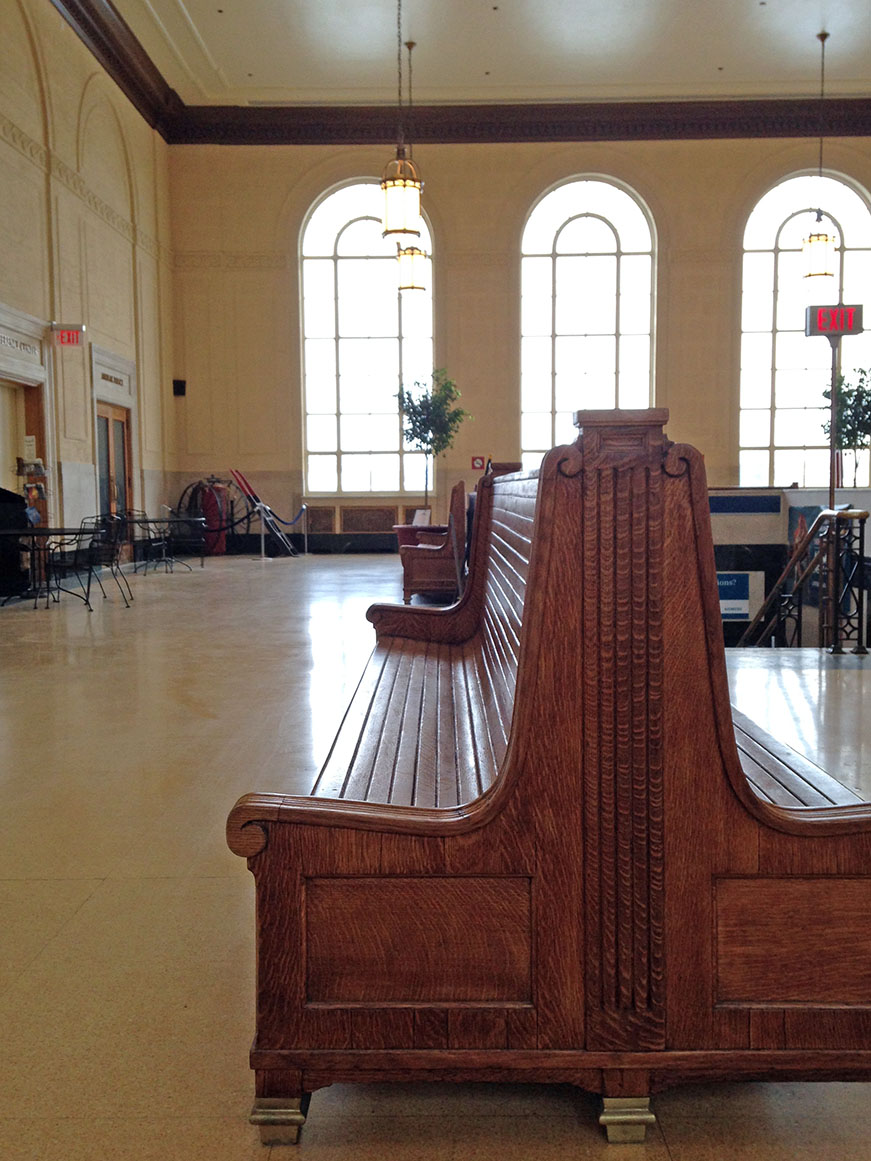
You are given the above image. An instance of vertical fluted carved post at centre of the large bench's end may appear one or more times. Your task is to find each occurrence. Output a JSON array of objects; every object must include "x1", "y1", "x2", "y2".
[{"x1": 580, "y1": 417, "x2": 669, "y2": 1048}]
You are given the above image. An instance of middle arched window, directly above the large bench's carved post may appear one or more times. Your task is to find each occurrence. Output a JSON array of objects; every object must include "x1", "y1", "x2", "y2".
[{"x1": 520, "y1": 178, "x2": 655, "y2": 467}]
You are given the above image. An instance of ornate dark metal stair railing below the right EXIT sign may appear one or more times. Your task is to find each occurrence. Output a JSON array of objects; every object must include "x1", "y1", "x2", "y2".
[{"x1": 737, "y1": 509, "x2": 869, "y2": 654}]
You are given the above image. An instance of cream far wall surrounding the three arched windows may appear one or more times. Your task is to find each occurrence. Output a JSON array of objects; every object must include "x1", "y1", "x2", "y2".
[{"x1": 170, "y1": 138, "x2": 871, "y2": 509}]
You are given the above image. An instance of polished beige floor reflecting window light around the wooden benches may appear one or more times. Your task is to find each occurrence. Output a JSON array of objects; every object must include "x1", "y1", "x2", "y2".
[{"x1": 0, "y1": 556, "x2": 871, "y2": 1161}]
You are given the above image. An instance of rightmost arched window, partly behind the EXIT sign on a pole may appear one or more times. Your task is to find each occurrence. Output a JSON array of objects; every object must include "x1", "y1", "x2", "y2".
[{"x1": 739, "y1": 175, "x2": 871, "y2": 488}]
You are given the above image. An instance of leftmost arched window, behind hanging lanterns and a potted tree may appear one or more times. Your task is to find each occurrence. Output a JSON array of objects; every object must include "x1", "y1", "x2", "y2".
[{"x1": 301, "y1": 181, "x2": 432, "y2": 495}]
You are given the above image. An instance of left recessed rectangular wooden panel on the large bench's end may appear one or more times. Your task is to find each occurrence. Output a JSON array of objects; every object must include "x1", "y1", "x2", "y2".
[{"x1": 305, "y1": 875, "x2": 532, "y2": 1005}]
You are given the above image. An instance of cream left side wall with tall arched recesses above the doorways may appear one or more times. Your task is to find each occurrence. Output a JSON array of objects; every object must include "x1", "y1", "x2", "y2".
[{"x1": 0, "y1": 0, "x2": 172, "y2": 524}]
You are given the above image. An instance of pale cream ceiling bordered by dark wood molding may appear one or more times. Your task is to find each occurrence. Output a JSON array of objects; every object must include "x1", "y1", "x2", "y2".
[{"x1": 110, "y1": 0, "x2": 871, "y2": 107}]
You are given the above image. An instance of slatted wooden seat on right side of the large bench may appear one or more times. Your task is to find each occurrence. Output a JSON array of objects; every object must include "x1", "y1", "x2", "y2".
[{"x1": 732, "y1": 706, "x2": 862, "y2": 808}]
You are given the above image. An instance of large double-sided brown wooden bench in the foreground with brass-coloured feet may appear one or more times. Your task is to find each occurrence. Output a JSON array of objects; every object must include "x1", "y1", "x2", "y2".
[{"x1": 228, "y1": 411, "x2": 871, "y2": 1141}]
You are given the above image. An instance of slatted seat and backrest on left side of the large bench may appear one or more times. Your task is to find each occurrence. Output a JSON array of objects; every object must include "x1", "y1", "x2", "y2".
[{"x1": 311, "y1": 478, "x2": 538, "y2": 807}]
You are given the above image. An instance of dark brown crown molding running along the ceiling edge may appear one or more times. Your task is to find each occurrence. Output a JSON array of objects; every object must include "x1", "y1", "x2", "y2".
[{"x1": 51, "y1": 0, "x2": 871, "y2": 145}]
